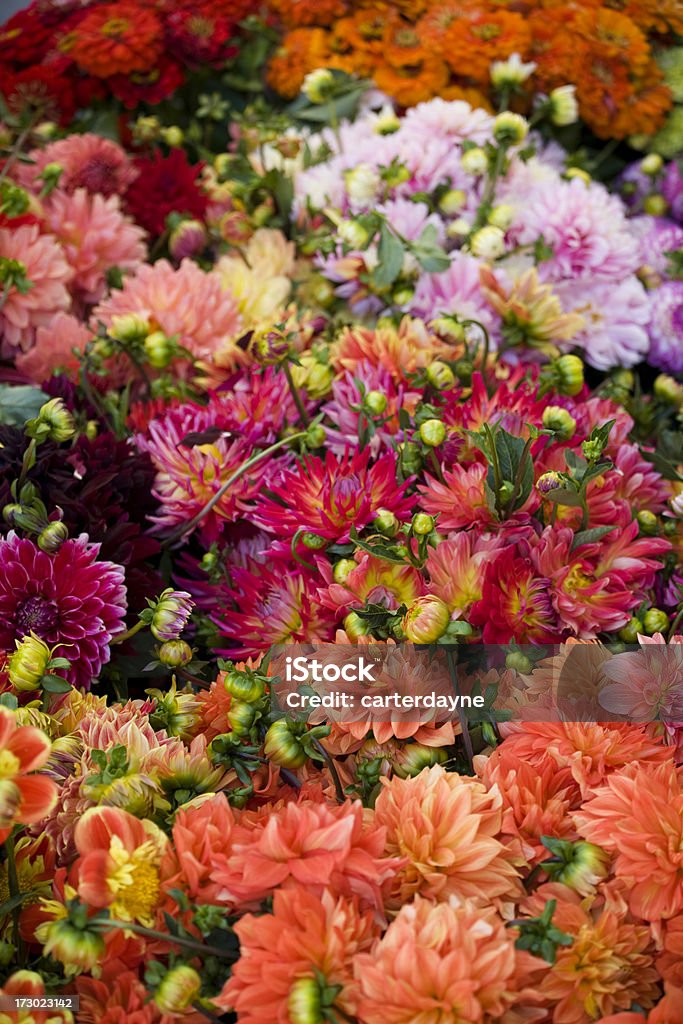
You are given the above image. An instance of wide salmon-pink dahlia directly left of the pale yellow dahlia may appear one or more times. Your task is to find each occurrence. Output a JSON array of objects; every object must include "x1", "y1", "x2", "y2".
[{"x1": 93, "y1": 259, "x2": 246, "y2": 369}]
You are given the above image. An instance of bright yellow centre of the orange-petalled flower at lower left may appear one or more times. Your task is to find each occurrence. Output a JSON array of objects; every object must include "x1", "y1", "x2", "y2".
[{"x1": 106, "y1": 836, "x2": 160, "y2": 926}]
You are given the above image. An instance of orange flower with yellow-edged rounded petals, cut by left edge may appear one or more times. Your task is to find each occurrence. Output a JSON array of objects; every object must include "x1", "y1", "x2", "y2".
[{"x1": 0, "y1": 708, "x2": 57, "y2": 843}]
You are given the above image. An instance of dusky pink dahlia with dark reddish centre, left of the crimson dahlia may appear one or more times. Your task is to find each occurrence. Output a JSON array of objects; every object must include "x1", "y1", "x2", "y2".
[{"x1": 16, "y1": 132, "x2": 138, "y2": 196}]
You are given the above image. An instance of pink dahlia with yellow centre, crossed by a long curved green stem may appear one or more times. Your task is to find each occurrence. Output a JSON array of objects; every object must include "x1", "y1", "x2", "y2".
[{"x1": 136, "y1": 404, "x2": 273, "y2": 544}]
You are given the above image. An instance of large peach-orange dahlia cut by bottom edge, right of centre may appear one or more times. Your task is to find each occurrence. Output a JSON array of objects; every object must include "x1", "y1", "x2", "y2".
[{"x1": 353, "y1": 896, "x2": 542, "y2": 1024}]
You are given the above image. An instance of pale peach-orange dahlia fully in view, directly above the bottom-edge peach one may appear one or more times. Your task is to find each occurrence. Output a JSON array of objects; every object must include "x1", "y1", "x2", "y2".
[{"x1": 375, "y1": 765, "x2": 519, "y2": 905}]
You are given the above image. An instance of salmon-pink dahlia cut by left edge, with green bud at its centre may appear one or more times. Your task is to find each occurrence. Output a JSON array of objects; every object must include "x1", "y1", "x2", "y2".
[{"x1": 0, "y1": 224, "x2": 74, "y2": 356}]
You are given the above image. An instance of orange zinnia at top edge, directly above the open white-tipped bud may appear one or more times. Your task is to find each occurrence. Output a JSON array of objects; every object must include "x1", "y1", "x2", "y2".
[{"x1": 443, "y1": 7, "x2": 531, "y2": 83}]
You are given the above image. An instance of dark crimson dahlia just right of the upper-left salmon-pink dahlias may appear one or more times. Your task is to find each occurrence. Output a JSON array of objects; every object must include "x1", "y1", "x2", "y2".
[{"x1": 126, "y1": 150, "x2": 208, "y2": 237}]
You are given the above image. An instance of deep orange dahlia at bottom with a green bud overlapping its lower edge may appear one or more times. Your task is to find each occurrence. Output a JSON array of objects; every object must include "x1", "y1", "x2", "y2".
[{"x1": 212, "y1": 887, "x2": 375, "y2": 1024}]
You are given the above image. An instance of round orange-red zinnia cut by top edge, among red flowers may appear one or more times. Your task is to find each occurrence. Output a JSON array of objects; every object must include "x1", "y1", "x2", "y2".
[{"x1": 70, "y1": 0, "x2": 163, "y2": 78}]
